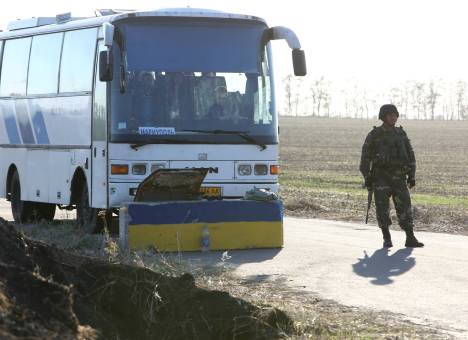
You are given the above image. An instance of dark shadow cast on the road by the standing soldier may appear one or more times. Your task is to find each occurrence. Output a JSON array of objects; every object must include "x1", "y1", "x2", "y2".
[{"x1": 352, "y1": 248, "x2": 416, "y2": 285}]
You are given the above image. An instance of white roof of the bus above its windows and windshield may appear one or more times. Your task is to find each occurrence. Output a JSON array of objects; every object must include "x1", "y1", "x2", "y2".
[{"x1": 0, "y1": 8, "x2": 266, "y2": 40}]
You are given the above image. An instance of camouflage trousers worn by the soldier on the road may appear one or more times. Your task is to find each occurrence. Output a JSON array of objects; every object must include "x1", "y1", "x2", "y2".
[{"x1": 374, "y1": 176, "x2": 414, "y2": 230}]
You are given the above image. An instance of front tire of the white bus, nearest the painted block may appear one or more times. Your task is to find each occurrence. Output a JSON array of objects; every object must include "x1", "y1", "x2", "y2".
[{"x1": 76, "y1": 183, "x2": 105, "y2": 234}]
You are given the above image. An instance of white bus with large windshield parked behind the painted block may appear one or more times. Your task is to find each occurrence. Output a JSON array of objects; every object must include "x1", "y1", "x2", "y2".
[{"x1": 0, "y1": 9, "x2": 306, "y2": 232}]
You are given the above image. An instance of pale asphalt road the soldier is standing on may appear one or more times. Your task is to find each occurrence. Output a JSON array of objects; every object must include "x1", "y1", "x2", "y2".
[{"x1": 0, "y1": 200, "x2": 468, "y2": 338}]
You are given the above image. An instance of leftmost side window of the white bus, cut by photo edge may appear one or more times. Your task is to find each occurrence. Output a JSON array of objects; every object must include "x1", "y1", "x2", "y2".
[{"x1": 0, "y1": 38, "x2": 31, "y2": 97}]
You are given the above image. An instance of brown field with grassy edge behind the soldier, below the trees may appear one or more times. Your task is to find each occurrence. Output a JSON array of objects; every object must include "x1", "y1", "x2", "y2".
[{"x1": 280, "y1": 117, "x2": 468, "y2": 235}]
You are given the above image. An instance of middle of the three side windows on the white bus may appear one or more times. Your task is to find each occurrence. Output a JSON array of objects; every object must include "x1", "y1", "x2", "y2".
[{"x1": 28, "y1": 33, "x2": 63, "y2": 95}]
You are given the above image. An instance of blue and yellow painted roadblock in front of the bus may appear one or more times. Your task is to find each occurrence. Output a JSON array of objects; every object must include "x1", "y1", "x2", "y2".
[{"x1": 120, "y1": 200, "x2": 283, "y2": 251}]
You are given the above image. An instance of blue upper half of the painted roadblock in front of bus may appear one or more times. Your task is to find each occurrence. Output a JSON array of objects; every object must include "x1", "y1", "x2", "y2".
[{"x1": 128, "y1": 200, "x2": 283, "y2": 225}]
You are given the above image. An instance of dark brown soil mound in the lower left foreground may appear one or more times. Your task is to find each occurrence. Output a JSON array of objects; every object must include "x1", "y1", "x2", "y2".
[{"x1": 0, "y1": 218, "x2": 292, "y2": 340}]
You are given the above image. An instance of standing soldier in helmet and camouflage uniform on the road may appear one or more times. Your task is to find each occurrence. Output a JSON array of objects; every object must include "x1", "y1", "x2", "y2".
[{"x1": 359, "y1": 104, "x2": 424, "y2": 248}]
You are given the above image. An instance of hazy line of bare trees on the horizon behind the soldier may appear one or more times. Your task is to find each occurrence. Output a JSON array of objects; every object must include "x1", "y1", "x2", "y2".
[{"x1": 280, "y1": 75, "x2": 468, "y2": 120}]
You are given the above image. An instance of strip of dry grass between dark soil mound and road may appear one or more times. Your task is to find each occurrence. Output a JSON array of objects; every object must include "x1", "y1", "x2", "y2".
[{"x1": 13, "y1": 222, "x2": 451, "y2": 339}]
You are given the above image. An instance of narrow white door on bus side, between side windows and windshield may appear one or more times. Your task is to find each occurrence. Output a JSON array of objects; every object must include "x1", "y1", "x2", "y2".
[{"x1": 91, "y1": 40, "x2": 108, "y2": 208}]
